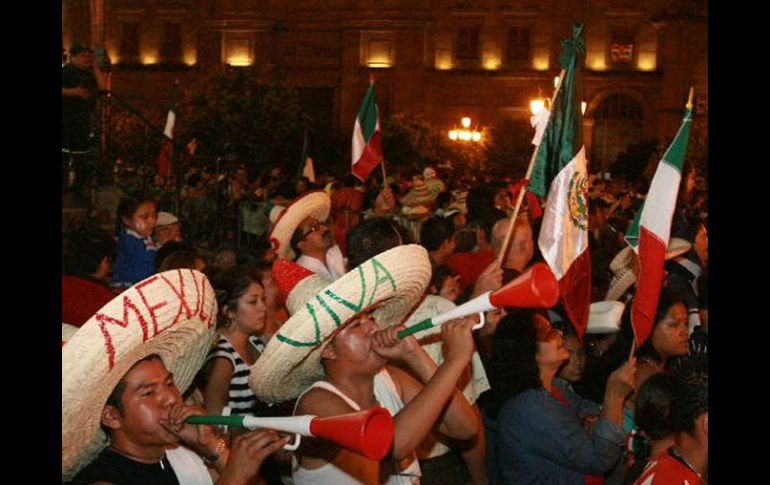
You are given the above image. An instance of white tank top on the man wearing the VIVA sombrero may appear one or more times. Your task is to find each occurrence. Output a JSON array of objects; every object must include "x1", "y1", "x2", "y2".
[{"x1": 292, "y1": 368, "x2": 420, "y2": 485}]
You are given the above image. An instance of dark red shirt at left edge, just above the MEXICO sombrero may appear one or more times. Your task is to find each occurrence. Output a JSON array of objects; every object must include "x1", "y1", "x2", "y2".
[{"x1": 61, "y1": 276, "x2": 115, "y2": 327}]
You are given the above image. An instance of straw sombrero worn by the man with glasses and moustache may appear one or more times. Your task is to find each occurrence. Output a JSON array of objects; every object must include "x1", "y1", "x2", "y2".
[{"x1": 270, "y1": 191, "x2": 332, "y2": 260}]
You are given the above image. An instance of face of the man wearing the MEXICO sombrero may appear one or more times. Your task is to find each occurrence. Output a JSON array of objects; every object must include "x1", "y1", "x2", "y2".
[{"x1": 110, "y1": 359, "x2": 182, "y2": 446}]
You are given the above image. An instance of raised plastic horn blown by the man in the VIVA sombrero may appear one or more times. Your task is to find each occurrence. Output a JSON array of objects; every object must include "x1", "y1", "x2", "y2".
[{"x1": 398, "y1": 263, "x2": 559, "y2": 338}]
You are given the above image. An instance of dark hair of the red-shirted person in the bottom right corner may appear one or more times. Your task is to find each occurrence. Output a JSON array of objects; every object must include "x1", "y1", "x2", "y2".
[{"x1": 673, "y1": 354, "x2": 709, "y2": 435}]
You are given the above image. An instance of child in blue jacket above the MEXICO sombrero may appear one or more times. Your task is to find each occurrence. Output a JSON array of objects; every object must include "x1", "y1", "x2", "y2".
[{"x1": 113, "y1": 197, "x2": 158, "y2": 288}]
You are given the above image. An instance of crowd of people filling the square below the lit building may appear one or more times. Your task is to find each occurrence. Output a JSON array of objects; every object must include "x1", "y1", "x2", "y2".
[{"x1": 62, "y1": 155, "x2": 708, "y2": 484}]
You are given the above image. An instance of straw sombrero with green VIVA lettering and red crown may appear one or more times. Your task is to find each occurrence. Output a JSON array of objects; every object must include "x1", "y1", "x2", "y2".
[{"x1": 249, "y1": 244, "x2": 431, "y2": 403}]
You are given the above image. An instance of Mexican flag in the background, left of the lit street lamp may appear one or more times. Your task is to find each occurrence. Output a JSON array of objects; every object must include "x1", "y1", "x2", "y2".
[{"x1": 352, "y1": 84, "x2": 383, "y2": 181}]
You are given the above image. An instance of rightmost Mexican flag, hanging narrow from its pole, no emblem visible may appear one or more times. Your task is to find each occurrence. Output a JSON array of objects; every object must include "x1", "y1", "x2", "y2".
[{"x1": 626, "y1": 89, "x2": 692, "y2": 346}]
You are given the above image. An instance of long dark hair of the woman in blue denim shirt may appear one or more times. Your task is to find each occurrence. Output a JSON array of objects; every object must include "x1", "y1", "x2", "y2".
[{"x1": 484, "y1": 308, "x2": 543, "y2": 418}]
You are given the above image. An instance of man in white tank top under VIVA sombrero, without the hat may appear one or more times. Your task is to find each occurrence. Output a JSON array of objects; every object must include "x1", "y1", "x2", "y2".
[{"x1": 293, "y1": 313, "x2": 478, "y2": 485}]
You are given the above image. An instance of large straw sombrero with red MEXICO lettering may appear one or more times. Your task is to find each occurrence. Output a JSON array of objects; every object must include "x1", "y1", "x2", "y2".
[{"x1": 62, "y1": 269, "x2": 217, "y2": 481}]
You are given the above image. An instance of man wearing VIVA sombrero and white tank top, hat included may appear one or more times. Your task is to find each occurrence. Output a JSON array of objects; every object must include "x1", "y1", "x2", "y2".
[{"x1": 249, "y1": 245, "x2": 479, "y2": 485}]
